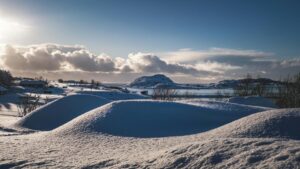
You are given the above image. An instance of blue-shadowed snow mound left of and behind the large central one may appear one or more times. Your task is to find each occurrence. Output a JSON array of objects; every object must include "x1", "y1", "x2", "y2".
[{"x1": 14, "y1": 94, "x2": 110, "y2": 131}]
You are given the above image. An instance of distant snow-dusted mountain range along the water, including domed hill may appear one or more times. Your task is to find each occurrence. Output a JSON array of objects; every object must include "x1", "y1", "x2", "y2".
[{"x1": 128, "y1": 74, "x2": 280, "y2": 89}]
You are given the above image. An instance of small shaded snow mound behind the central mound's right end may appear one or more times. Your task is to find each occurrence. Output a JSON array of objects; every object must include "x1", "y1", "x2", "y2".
[{"x1": 228, "y1": 96, "x2": 277, "y2": 108}]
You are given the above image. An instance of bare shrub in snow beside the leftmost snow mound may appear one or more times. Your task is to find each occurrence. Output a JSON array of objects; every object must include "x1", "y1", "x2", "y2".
[{"x1": 17, "y1": 94, "x2": 40, "y2": 117}]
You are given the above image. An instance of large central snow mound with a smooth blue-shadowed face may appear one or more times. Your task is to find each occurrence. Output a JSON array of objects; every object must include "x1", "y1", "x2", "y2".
[{"x1": 54, "y1": 100, "x2": 261, "y2": 138}]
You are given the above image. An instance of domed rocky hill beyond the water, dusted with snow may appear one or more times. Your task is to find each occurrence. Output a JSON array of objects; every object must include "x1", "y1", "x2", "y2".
[{"x1": 129, "y1": 74, "x2": 175, "y2": 88}]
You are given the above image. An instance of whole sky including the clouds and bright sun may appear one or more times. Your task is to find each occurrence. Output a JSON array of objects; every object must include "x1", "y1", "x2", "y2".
[{"x1": 0, "y1": 0, "x2": 300, "y2": 83}]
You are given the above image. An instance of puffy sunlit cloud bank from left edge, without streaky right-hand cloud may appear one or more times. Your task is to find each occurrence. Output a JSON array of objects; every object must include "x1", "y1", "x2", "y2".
[{"x1": 2, "y1": 44, "x2": 220, "y2": 75}]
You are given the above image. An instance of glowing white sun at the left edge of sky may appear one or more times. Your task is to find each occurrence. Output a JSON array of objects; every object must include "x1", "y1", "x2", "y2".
[{"x1": 0, "y1": 16, "x2": 29, "y2": 42}]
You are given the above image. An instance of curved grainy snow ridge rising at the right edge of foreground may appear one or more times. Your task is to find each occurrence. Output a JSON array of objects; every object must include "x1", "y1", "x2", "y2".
[{"x1": 210, "y1": 108, "x2": 300, "y2": 140}]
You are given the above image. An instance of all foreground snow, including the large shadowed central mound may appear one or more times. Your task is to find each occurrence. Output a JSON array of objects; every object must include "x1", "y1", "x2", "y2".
[{"x1": 0, "y1": 100, "x2": 300, "y2": 168}]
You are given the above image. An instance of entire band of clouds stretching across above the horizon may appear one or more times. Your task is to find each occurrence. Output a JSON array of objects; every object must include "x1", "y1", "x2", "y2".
[{"x1": 0, "y1": 44, "x2": 300, "y2": 81}]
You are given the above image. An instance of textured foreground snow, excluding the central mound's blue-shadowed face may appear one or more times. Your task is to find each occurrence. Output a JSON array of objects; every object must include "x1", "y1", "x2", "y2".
[{"x1": 0, "y1": 102, "x2": 300, "y2": 168}]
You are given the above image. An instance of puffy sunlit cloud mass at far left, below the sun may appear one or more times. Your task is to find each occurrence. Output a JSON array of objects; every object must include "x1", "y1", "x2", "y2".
[{"x1": 2, "y1": 44, "x2": 116, "y2": 72}]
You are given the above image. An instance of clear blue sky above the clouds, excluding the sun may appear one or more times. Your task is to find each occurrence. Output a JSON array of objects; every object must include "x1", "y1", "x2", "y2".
[{"x1": 0, "y1": 0, "x2": 300, "y2": 82}]
